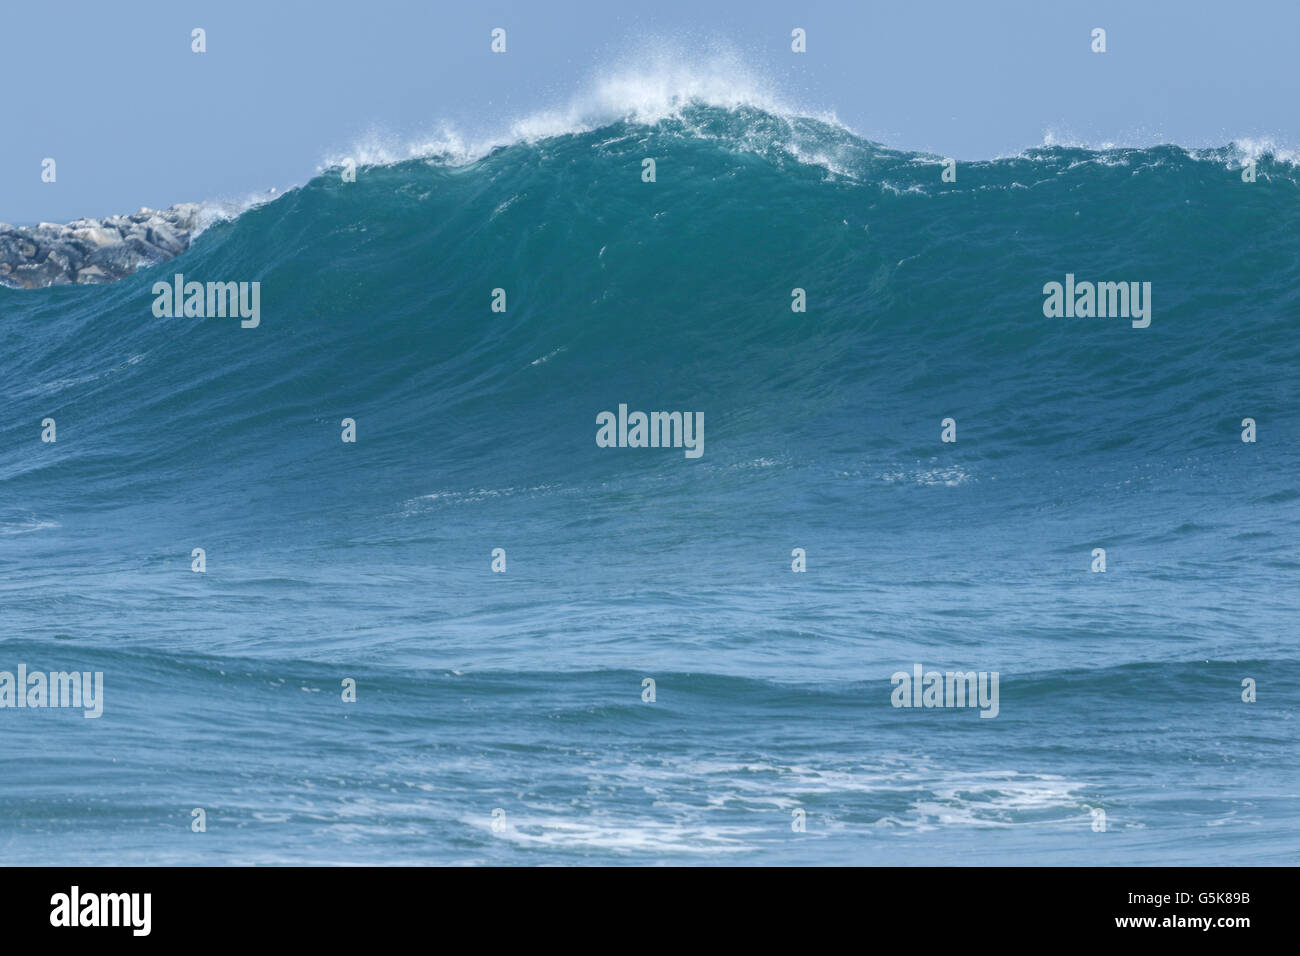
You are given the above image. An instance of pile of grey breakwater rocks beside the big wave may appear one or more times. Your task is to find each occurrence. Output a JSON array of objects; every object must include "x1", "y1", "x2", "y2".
[{"x1": 0, "y1": 203, "x2": 199, "y2": 289}]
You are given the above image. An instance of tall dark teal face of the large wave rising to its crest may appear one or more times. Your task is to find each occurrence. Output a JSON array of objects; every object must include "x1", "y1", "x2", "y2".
[{"x1": 3, "y1": 89, "x2": 1297, "y2": 502}]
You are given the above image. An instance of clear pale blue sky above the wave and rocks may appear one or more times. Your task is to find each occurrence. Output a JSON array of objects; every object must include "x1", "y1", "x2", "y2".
[{"x1": 0, "y1": 0, "x2": 1300, "y2": 224}]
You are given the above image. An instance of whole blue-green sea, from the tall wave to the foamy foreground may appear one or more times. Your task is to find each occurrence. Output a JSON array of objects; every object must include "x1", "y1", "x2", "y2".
[{"x1": 0, "y1": 103, "x2": 1300, "y2": 865}]
